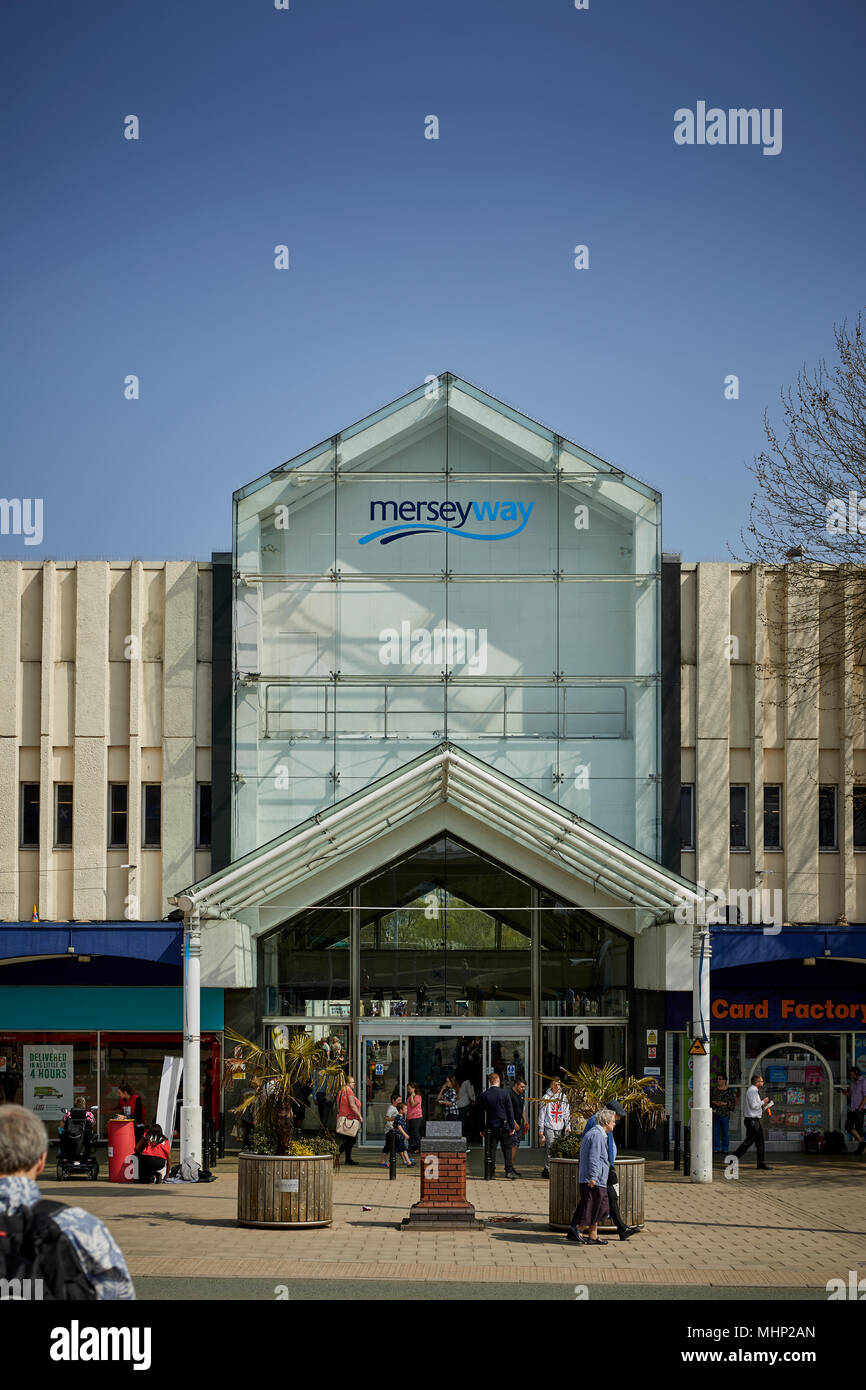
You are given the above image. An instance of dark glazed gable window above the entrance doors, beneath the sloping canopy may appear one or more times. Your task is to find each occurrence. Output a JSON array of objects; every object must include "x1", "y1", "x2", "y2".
[{"x1": 260, "y1": 835, "x2": 632, "y2": 1020}]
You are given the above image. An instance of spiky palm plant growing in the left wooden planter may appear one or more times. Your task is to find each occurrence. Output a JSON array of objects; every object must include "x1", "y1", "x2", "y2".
[{"x1": 222, "y1": 1029, "x2": 346, "y2": 1155}]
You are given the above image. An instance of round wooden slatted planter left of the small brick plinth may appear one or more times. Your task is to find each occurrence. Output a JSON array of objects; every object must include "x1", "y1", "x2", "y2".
[{"x1": 238, "y1": 1154, "x2": 334, "y2": 1227}]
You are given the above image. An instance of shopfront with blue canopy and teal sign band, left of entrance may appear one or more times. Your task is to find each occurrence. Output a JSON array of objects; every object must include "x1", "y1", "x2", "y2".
[{"x1": 0, "y1": 922, "x2": 224, "y2": 1137}]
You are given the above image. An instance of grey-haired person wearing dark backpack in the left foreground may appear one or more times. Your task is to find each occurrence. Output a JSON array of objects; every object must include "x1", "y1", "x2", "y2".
[{"x1": 0, "y1": 1105, "x2": 135, "y2": 1302}]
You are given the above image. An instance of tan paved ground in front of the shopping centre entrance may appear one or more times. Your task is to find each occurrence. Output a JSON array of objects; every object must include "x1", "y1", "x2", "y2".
[{"x1": 40, "y1": 1151, "x2": 866, "y2": 1300}]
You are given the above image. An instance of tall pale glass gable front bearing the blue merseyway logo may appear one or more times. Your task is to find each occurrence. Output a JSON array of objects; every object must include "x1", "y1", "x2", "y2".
[{"x1": 232, "y1": 374, "x2": 660, "y2": 858}]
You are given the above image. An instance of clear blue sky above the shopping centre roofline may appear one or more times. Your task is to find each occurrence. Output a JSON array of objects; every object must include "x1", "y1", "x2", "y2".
[{"x1": 0, "y1": 0, "x2": 866, "y2": 559}]
